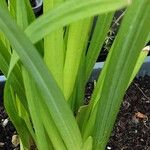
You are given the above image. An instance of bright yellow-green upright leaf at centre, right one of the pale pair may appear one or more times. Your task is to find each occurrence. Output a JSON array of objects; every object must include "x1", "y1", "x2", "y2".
[{"x1": 63, "y1": 18, "x2": 92, "y2": 100}]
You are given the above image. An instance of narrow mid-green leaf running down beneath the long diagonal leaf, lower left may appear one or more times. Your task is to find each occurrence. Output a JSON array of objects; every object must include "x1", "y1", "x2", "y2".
[{"x1": 22, "y1": 68, "x2": 48, "y2": 150}]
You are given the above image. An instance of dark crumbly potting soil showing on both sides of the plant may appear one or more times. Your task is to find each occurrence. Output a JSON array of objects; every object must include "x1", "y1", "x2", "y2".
[{"x1": 0, "y1": 76, "x2": 150, "y2": 150}]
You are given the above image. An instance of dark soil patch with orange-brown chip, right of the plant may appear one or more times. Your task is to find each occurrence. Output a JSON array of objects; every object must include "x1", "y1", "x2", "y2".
[{"x1": 107, "y1": 76, "x2": 150, "y2": 150}]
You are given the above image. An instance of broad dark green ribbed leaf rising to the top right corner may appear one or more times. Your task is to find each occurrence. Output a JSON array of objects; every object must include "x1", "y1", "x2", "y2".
[{"x1": 84, "y1": 0, "x2": 150, "y2": 149}]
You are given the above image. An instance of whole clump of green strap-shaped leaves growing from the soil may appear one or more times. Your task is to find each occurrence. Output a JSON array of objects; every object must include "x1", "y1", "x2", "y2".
[{"x1": 0, "y1": 0, "x2": 150, "y2": 150}]
